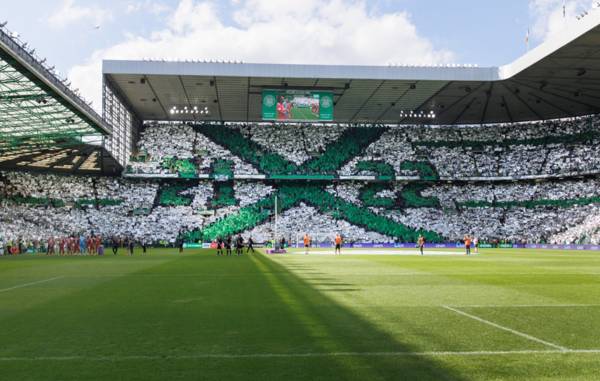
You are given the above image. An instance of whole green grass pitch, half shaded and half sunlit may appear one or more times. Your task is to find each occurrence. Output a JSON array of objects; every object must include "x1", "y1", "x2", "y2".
[{"x1": 0, "y1": 249, "x2": 600, "y2": 381}]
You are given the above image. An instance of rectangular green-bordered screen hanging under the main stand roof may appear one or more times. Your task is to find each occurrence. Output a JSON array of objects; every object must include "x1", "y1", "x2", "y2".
[{"x1": 262, "y1": 90, "x2": 333, "y2": 122}]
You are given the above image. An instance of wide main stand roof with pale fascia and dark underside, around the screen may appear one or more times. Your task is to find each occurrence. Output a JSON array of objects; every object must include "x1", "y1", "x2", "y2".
[{"x1": 103, "y1": 12, "x2": 600, "y2": 124}]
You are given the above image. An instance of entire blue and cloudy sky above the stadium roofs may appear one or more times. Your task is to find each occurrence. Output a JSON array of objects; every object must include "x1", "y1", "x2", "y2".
[{"x1": 0, "y1": 0, "x2": 597, "y2": 110}]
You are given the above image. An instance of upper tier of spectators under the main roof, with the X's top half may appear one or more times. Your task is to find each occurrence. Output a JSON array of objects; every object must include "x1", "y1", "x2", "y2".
[{"x1": 126, "y1": 117, "x2": 600, "y2": 181}]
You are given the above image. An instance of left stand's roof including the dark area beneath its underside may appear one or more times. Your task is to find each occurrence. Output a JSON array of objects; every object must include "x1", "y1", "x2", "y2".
[{"x1": 0, "y1": 27, "x2": 121, "y2": 174}]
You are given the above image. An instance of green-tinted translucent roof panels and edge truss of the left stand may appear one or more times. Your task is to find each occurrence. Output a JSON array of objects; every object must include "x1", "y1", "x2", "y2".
[{"x1": 0, "y1": 28, "x2": 111, "y2": 154}]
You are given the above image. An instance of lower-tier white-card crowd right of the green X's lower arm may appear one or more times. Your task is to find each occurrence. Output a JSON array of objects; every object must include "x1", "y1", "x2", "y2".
[{"x1": 328, "y1": 179, "x2": 600, "y2": 244}]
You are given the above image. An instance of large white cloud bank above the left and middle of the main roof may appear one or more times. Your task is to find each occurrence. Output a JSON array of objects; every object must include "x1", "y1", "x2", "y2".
[{"x1": 69, "y1": 0, "x2": 454, "y2": 107}]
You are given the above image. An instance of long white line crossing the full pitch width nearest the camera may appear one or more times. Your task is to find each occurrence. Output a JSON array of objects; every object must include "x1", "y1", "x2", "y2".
[{"x1": 0, "y1": 349, "x2": 600, "y2": 362}]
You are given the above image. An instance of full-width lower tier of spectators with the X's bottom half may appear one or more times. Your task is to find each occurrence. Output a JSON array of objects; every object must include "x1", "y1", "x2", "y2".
[{"x1": 0, "y1": 172, "x2": 600, "y2": 244}]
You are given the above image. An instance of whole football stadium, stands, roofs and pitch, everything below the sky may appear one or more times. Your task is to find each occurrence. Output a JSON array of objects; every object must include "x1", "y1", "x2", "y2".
[{"x1": 0, "y1": 3, "x2": 600, "y2": 380}]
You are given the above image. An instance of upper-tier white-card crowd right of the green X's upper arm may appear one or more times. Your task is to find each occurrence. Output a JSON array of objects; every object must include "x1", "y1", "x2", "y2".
[{"x1": 340, "y1": 116, "x2": 600, "y2": 179}]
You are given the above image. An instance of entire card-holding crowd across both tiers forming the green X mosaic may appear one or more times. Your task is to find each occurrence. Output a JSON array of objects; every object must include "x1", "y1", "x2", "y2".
[{"x1": 0, "y1": 117, "x2": 600, "y2": 246}]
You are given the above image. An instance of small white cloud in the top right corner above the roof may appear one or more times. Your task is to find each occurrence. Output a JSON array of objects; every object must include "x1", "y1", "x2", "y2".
[{"x1": 529, "y1": 0, "x2": 597, "y2": 41}]
